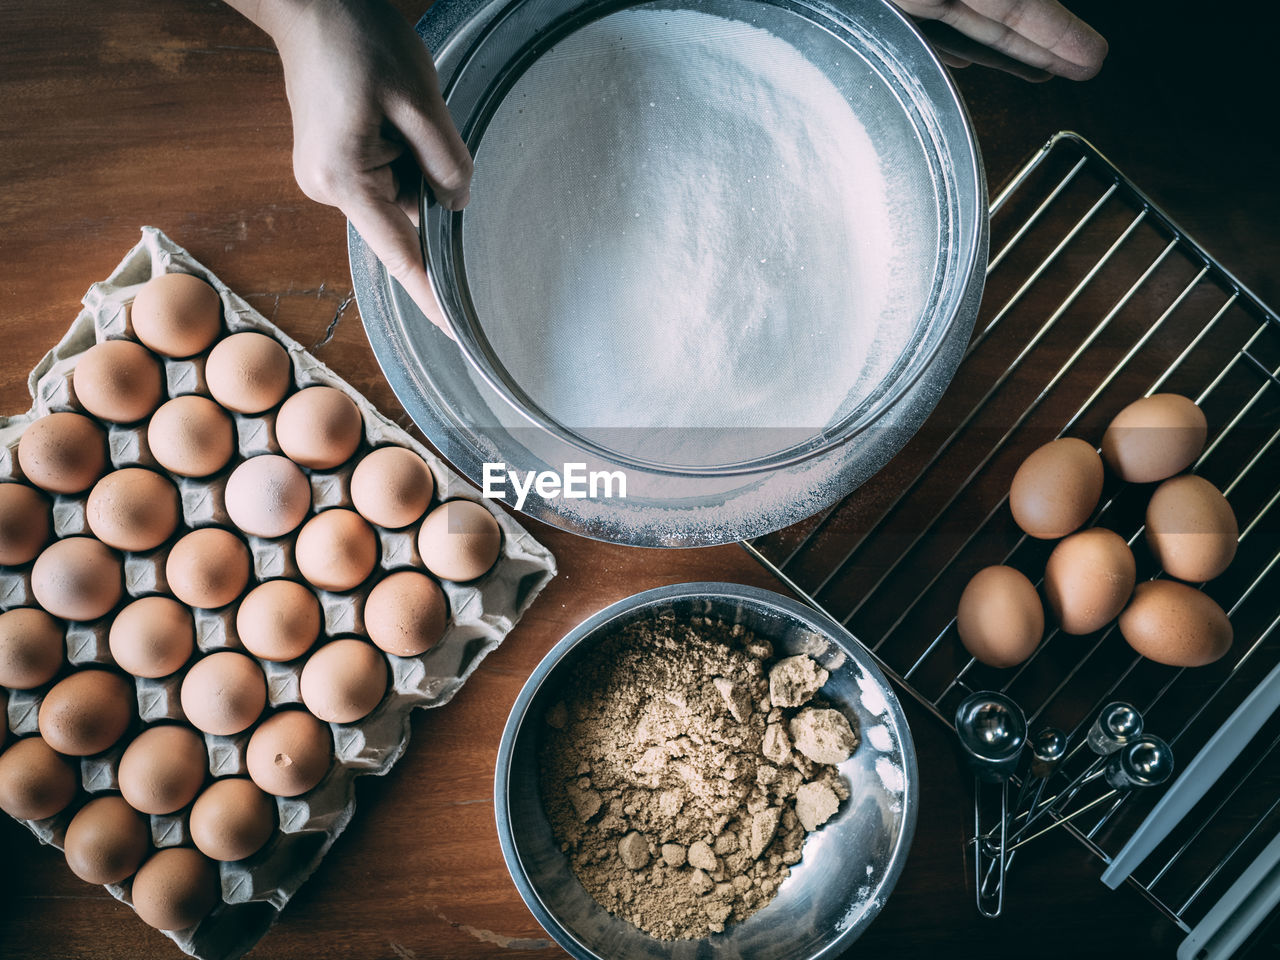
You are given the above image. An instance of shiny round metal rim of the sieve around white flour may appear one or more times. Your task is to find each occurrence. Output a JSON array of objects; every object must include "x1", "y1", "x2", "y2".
[{"x1": 419, "y1": 0, "x2": 987, "y2": 477}]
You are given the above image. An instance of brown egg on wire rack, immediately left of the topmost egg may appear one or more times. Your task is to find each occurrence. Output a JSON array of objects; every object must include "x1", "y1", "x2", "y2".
[{"x1": 1009, "y1": 436, "x2": 1102, "y2": 540}]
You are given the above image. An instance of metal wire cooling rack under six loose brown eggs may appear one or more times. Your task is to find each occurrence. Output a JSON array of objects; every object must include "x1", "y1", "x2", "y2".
[{"x1": 744, "y1": 132, "x2": 1280, "y2": 931}]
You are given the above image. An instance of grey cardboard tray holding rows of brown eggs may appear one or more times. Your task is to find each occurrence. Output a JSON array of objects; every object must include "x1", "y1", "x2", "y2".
[{"x1": 0, "y1": 227, "x2": 556, "y2": 960}]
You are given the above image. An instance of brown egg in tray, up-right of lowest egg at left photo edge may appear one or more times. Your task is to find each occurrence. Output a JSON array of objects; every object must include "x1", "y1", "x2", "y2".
[{"x1": 38, "y1": 669, "x2": 136, "y2": 756}]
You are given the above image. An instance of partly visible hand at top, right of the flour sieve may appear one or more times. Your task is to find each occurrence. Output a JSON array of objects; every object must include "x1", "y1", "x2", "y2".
[{"x1": 893, "y1": 0, "x2": 1107, "y2": 81}]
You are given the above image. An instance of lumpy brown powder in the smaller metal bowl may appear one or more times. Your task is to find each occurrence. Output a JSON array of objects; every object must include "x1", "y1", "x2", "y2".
[{"x1": 541, "y1": 616, "x2": 858, "y2": 940}]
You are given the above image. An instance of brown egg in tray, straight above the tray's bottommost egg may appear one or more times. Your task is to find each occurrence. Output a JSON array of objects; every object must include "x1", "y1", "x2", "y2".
[{"x1": 119, "y1": 723, "x2": 209, "y2": 814}]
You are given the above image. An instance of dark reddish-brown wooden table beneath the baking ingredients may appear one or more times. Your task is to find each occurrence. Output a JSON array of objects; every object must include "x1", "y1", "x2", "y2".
[{"x1": 0, "y1": 0, "x2": 1280, "y2": 960}]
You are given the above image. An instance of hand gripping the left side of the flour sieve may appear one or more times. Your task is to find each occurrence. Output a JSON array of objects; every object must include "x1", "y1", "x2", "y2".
[{"x1": 229, "y1": 0, "x2": 471, "y2": 333}]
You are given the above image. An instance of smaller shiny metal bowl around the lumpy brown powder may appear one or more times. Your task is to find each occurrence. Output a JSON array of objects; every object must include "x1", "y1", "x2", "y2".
[{"x1": 494, "y1": 584, "x2": 919, "y2": 960}]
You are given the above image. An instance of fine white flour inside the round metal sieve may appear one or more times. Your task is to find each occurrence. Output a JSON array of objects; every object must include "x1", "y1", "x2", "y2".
[{"x1": 463, "y1": 8, "x2": 911, "y2": 463}]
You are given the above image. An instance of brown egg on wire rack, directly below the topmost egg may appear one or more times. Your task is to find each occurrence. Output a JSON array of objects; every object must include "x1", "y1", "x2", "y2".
[{"x1": 1147, "y1": 474, "x2": 1240, "y2": 584}]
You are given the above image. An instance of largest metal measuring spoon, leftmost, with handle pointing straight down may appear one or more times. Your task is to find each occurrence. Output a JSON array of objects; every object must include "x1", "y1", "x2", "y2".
[{"x1": 955, "y1": 691, "x2": 1027, "y2": 918}]
